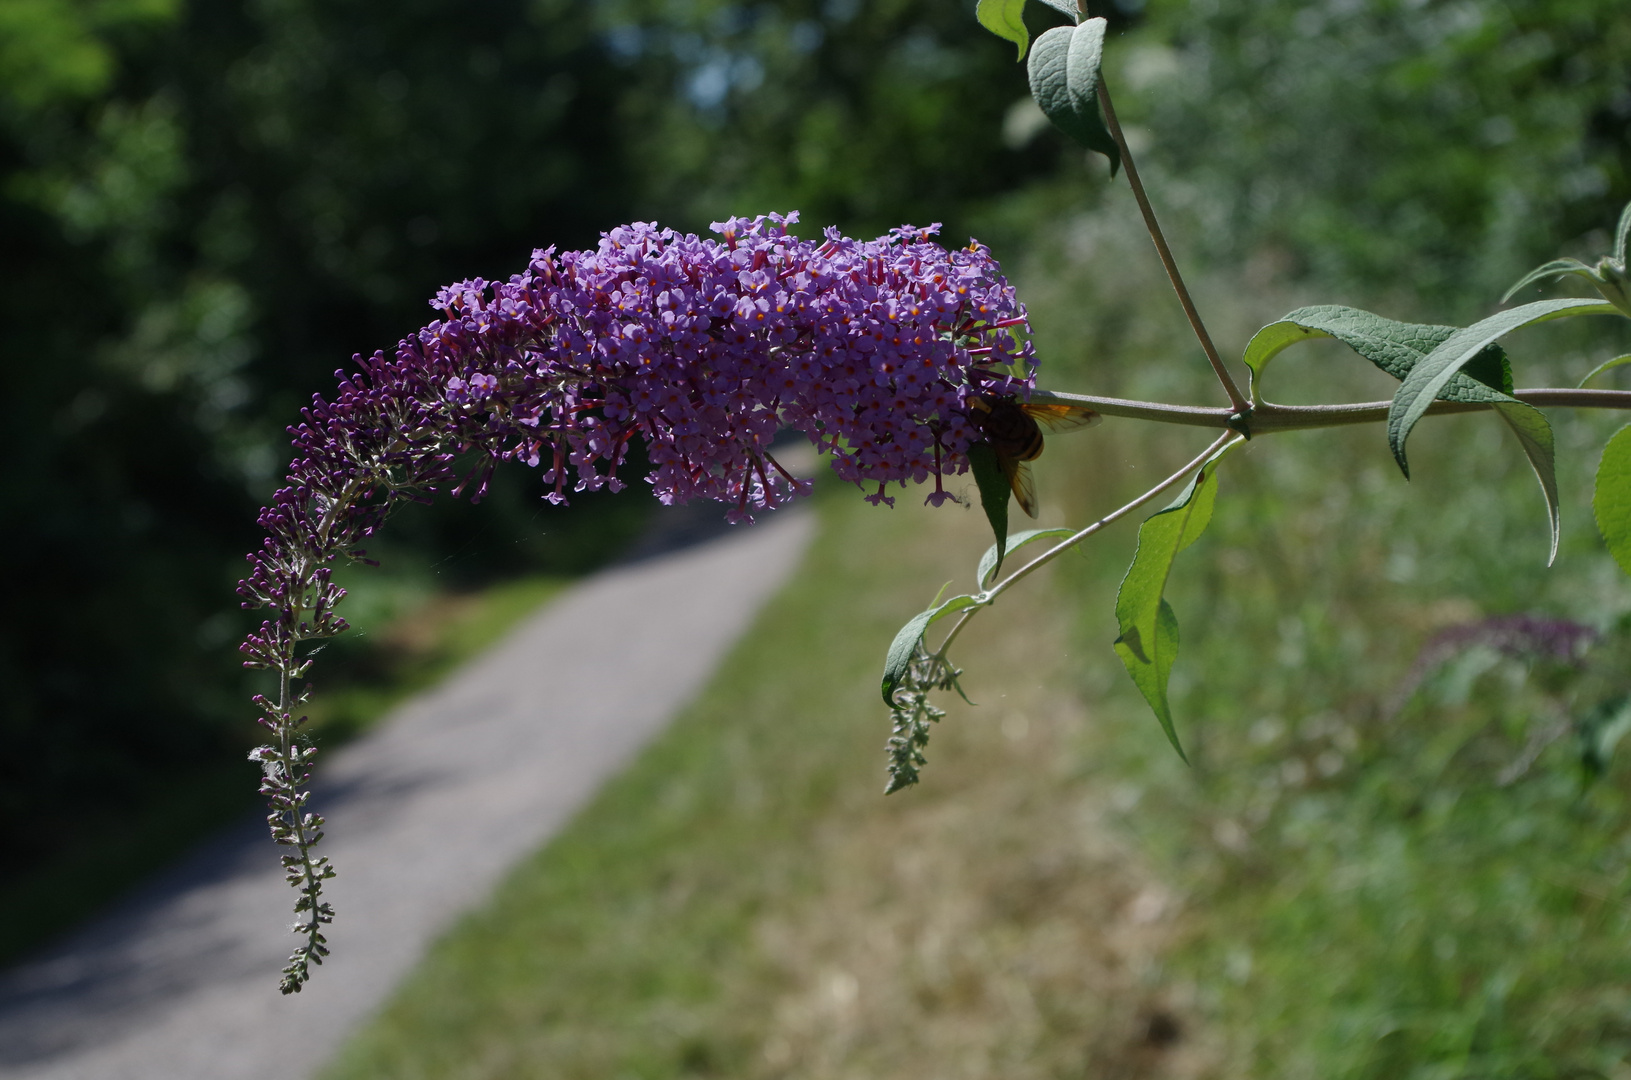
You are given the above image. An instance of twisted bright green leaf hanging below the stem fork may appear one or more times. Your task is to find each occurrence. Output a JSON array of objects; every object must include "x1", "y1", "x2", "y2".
[{"x1": 1116, "y1": 444, "x2": 1240, "y2": 762}]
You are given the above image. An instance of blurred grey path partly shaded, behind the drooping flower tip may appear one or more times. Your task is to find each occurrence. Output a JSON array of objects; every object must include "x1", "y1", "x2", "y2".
[{"x1": 0, "y1": 511, "x2": 814, "y2": 1080}]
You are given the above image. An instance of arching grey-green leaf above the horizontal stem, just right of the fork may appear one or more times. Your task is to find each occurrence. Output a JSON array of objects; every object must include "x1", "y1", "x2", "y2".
[{"x1": 1243, "y1": 303, "x2": 1512, "y2": 401}]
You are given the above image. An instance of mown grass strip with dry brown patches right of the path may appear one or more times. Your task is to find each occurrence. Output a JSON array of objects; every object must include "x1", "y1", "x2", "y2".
[{"x1": 325, "y1": 479, "x2": 1213, "y2": 1080}]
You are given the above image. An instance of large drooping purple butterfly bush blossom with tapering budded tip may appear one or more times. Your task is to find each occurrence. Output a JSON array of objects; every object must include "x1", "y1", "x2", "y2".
[{"x1": 238, "y1": 214, "x2": 1036, "y2": 994}]
